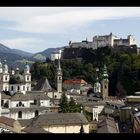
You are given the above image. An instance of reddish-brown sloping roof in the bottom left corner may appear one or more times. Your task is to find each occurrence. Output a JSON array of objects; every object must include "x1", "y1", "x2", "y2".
[{"x1": 0, "y1": 116, "x2": 15, "y2": 127}]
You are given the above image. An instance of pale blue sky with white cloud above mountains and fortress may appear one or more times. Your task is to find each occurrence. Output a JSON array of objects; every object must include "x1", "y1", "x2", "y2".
[{"x1": 0, "y1": 7, "x2": 140, "y2": 53}]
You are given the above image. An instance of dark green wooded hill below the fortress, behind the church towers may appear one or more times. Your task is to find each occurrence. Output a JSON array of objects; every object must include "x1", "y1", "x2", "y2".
[{"x1": 32, "y1": 47, "x2": 140, "y2": 96}]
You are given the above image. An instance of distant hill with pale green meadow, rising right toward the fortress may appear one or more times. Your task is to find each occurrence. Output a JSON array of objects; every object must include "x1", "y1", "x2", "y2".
[{"x1": 32, "y1": 46, "x2": 67, "y2": 60}]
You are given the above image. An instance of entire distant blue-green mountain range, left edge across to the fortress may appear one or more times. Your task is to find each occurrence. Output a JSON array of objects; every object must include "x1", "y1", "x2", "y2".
[{"x1": 0, "y1": 43, "x2": 67, "y2": 68}]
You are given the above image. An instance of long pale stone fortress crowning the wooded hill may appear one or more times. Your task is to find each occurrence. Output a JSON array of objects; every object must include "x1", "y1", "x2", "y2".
[{"x1": 69, "y1": 33, "x2": 136, "y2": 49}]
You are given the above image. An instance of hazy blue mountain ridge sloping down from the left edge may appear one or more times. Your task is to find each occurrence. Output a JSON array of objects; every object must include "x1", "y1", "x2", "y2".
[{"x1": 0, "y1": 43, "x2": 33, "y2": 57}]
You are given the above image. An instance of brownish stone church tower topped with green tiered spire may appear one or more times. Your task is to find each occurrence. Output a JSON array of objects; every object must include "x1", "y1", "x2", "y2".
[{"x1": 101, "y1": 65, "x2": 109, "y2": 99}]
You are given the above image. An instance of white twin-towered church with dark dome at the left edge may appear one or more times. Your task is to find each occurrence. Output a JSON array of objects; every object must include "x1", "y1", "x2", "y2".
[{"x1": 0, "y1": 62, "x2": 31, "y2": 95}]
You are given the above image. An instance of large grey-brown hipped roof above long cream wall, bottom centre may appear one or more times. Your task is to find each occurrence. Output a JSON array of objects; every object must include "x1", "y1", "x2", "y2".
[{"x1": 29, "y1": 113, "x2": 88, "y2": 126}]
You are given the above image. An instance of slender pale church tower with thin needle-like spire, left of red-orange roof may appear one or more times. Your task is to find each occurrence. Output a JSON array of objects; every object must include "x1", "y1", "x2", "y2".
[{"x1": 56, "y1": 59, "x2": 62, "y2": 93}]
